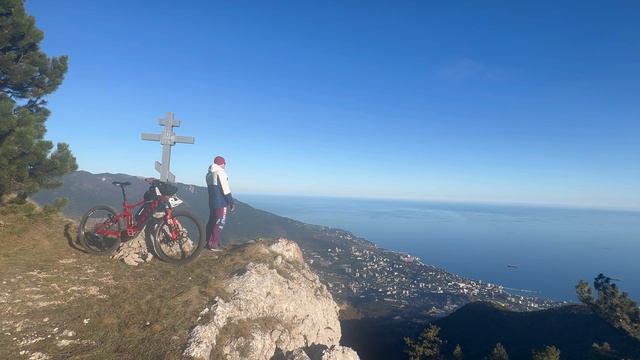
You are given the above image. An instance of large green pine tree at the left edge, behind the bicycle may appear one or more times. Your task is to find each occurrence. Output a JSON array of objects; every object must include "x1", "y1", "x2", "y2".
[{"x1": 0, "y1": 0, "x2": 77, "y2": 204}]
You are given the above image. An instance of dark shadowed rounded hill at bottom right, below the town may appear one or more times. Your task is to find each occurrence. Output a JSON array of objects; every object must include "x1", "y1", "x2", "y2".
[{"x1": 434, "y1": 302, "x2": 640, "y2": 360}]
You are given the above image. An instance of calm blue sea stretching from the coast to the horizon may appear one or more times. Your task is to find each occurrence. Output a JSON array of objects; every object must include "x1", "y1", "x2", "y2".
[{"x1": 239, "y1": 195, "x2": 640, "y2": 301}]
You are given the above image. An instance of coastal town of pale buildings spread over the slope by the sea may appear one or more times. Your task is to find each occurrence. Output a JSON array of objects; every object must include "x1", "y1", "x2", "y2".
[{"x1": 303, "y1": 228, "x2": 562, "y2": 316}]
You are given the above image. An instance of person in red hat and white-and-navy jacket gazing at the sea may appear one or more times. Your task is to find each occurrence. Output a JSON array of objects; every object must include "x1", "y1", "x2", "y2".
[{"x1": 207, "y1": 156, "x2": 236, "y2": 251}]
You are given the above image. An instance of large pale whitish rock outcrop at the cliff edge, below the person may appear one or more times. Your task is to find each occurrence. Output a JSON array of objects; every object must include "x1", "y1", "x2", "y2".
[{"x1": 183, "y1": 239, "x2": 358, "y2": 360}]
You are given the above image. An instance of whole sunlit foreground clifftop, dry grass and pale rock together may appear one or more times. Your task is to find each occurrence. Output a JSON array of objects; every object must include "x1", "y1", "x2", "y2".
[{"x1": 0, "y1": 205, "x2": 358, "y2": 360}]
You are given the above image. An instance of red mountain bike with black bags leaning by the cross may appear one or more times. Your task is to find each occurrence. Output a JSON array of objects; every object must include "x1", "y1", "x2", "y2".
[{"x1": 78, "y1": 179, "x2": 204, "y2": 265}]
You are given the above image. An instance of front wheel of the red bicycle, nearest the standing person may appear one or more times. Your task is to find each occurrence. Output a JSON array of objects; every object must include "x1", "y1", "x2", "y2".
[{"x1": 153, "y1": 211, "x2": 204, "y2": 265}]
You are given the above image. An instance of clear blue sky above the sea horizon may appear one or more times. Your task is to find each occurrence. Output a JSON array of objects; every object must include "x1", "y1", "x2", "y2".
[{"x1": 27, "y1": 0, "x2": 640, "y2": 209}]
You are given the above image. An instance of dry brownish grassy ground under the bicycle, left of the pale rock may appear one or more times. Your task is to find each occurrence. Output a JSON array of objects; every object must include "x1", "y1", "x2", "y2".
[{"x1": 0, "y1": 207, "x2": 282, "y2": 359}]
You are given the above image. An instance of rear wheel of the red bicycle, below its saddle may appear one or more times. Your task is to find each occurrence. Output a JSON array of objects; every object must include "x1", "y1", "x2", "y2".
[{"x1": 78, "y1": 205, "x2": 122, "y2": 255}]
